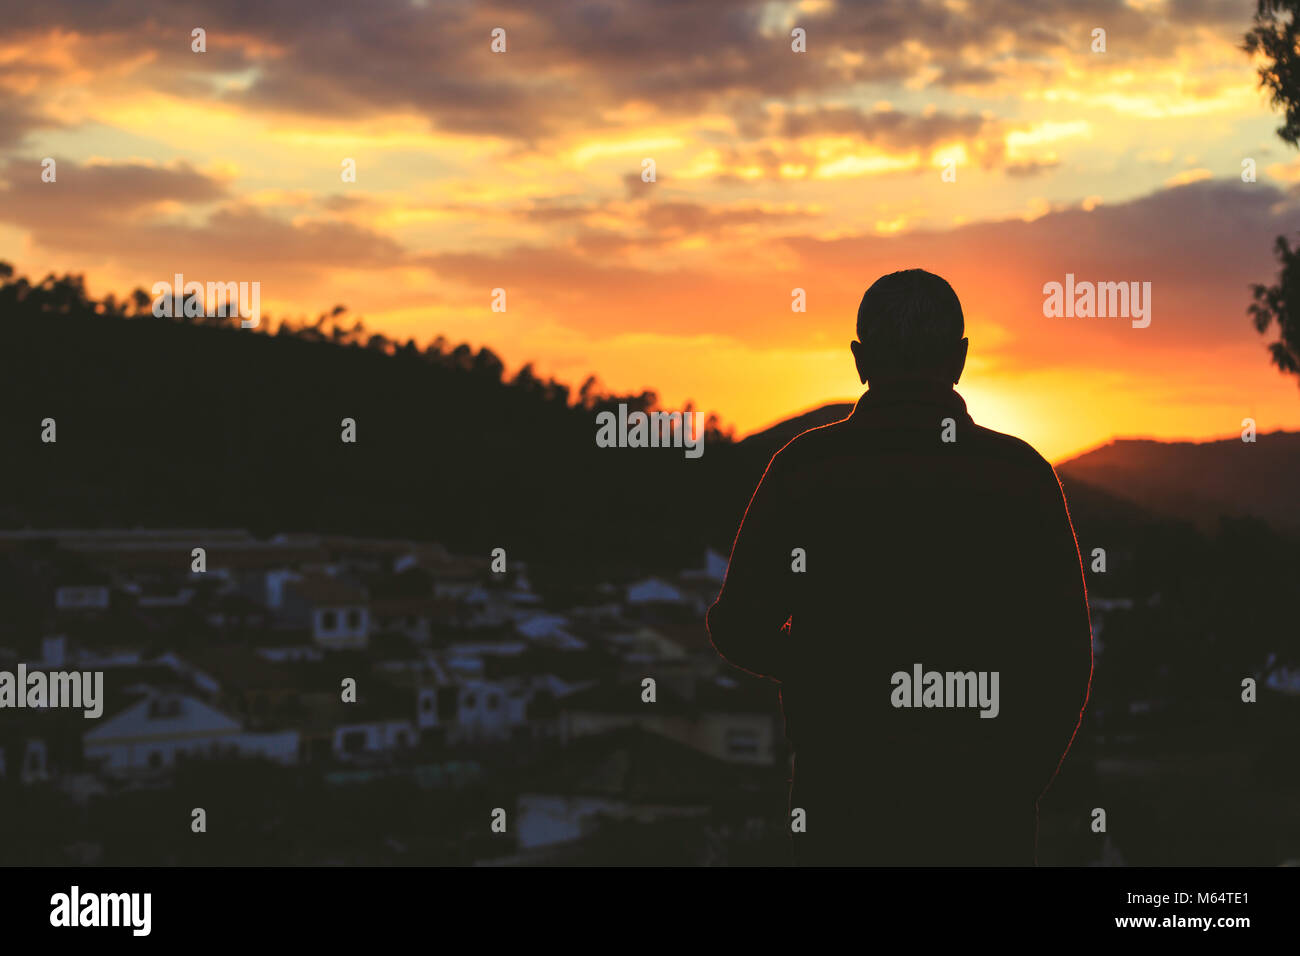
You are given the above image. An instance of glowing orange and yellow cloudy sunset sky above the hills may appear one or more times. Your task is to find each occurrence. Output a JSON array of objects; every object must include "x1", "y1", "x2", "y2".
[{"x1": 0, "y1": 0, "x2": 1300, "y2": 460}]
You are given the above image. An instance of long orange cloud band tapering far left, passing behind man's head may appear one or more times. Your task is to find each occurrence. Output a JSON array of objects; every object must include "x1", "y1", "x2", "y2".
[{"x1": 416, "y1": 181, "x2": 1300, "y2": 366}]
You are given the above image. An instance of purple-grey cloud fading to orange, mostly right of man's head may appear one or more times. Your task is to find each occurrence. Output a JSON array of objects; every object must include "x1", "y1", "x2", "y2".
[{"x1": 787, "y1": 179, "x2": 1300, "y2": 365}]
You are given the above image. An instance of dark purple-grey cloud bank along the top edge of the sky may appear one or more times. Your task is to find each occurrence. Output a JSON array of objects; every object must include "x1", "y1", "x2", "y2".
[{"x1": 7, "y1": 0, "x2": 1249, "y2": 144}]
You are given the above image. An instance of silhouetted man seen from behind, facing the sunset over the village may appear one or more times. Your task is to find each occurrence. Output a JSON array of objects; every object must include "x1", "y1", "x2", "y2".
[{"x1": 707, "y1": 269, "x2": 1092, "y2": 865}]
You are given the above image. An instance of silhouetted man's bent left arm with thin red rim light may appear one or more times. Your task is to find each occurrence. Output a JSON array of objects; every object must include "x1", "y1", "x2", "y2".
[{"x1": 705, "y1": 453, "x2": 792, "y2": 680}]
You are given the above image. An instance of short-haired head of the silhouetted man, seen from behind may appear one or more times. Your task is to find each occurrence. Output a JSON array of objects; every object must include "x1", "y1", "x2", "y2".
[{"x1": 849, "y1": 269, "x2": 970, "y2": 385}]
